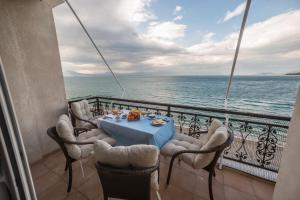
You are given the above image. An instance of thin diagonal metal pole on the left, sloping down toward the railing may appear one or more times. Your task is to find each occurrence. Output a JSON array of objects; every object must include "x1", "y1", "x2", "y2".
[{"x1": 65, "y1": 0, "x2": 125, "y2": 97}]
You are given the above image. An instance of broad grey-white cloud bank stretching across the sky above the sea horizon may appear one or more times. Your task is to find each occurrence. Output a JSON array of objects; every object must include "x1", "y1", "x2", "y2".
[{"x1": 54, "y1": 0, "x2": 300, "y2": 75}]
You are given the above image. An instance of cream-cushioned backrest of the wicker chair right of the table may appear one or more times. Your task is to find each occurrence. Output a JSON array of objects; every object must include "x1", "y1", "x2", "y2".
[{"x1": 194, "y1": 121, "x2": 233, "y2": 169}]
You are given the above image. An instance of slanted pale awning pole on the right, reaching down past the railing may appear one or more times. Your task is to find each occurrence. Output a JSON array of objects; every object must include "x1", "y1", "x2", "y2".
[{"x1": 219, "y1": 0, "x2": 251, "y2": 169}]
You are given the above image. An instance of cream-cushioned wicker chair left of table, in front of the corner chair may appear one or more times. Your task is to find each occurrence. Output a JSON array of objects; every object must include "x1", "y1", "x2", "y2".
[{"x1": 47, "y1": 115, "x2": 116, "y2": 192}]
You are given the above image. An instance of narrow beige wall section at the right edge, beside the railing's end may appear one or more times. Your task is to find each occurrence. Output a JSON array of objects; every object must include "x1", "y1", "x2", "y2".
[{"x1": 273, "y1": 87, "x2": 300, "y2": 200}]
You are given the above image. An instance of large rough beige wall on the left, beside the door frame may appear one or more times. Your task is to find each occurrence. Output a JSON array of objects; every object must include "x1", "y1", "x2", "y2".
[{"x1": 0, "y1": 0, "x2": 66, "y2": 162}]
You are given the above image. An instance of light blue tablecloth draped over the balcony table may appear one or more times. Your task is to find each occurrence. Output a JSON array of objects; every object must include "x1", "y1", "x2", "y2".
[{"x1": 99, "y1": 115, "x2": 175, "y2": 148}]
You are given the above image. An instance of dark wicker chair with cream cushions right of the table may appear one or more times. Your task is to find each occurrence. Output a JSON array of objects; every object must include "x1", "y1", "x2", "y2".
[{"x1": 161, "y1": 120, "x2": 234, "y2": 200}]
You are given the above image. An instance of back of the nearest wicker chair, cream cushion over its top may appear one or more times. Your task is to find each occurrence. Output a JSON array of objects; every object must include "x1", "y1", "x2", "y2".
[{"x1": 94, "y1": 141, "x2": 159, "y2": 199}]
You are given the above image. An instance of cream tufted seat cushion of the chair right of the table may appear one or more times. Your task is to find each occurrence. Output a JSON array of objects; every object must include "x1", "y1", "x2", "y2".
[{"x1": 161, "y1": 134, "x2": 203, "y2": 165}]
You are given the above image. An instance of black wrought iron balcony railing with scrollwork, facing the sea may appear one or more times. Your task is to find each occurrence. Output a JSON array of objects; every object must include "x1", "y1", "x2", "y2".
[{"x1": 69, "y1": 96, "x2": 290, "y2": 179}]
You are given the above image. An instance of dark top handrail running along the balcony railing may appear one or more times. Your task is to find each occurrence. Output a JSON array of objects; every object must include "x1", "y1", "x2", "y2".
[{"x1": 68, "y1": 96, "x2": 291, "y2": 121}]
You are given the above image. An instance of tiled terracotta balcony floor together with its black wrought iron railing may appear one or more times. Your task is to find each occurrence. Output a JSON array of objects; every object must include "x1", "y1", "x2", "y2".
[{"x1": 26, "y1": 96, "x2": 290, "y2": 200}]
